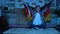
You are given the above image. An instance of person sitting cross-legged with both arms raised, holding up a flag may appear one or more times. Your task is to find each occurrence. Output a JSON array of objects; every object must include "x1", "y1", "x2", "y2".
[{"x1": 24, "y1": 2, "x2": 51, "y2": 30}]
